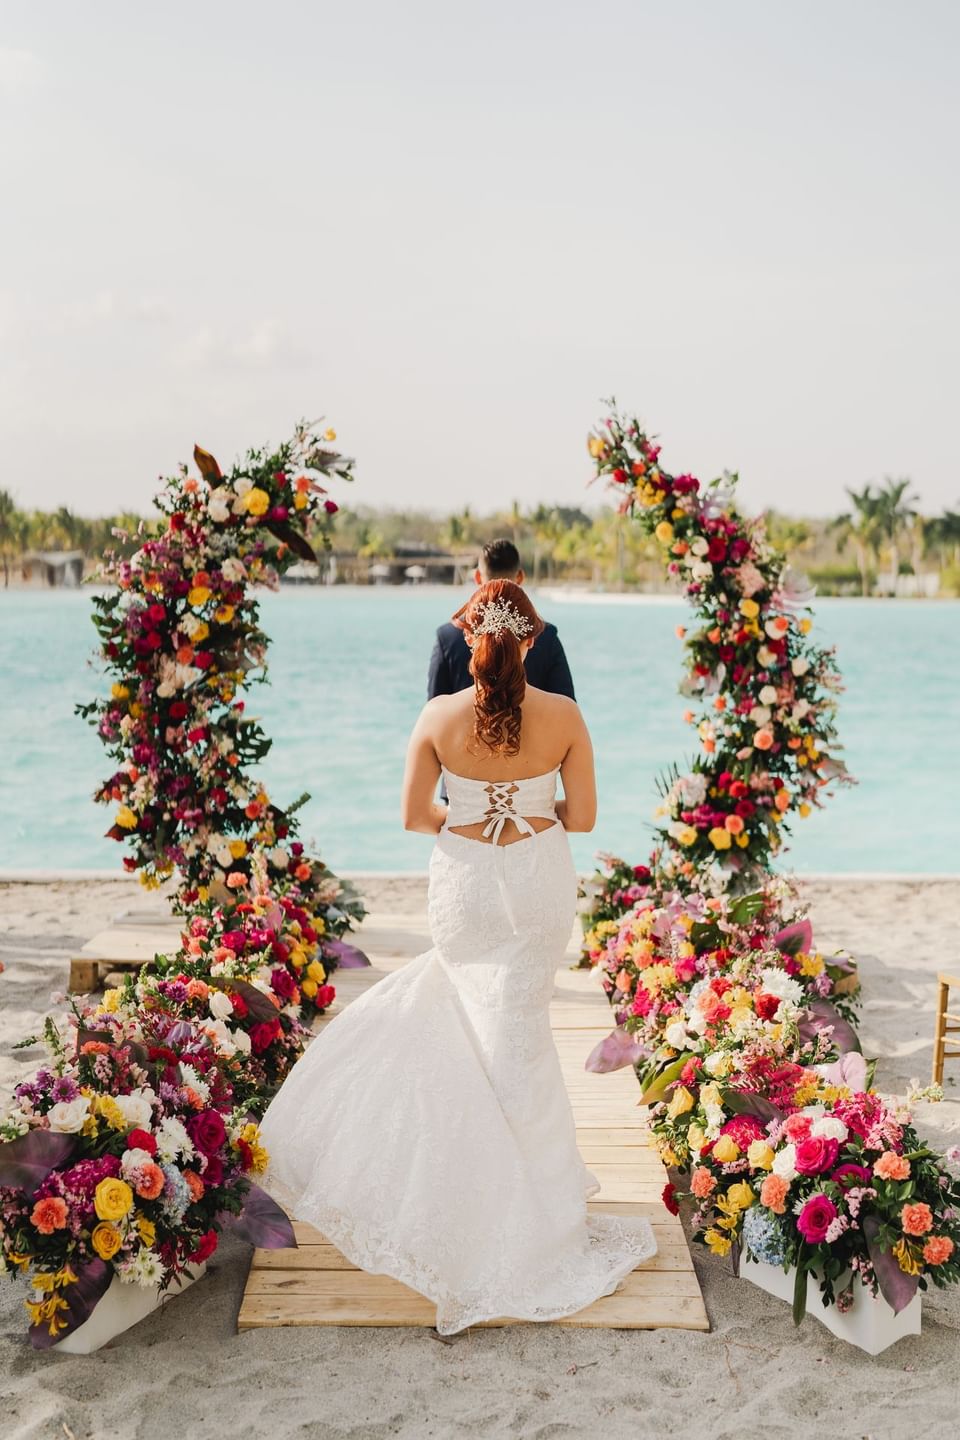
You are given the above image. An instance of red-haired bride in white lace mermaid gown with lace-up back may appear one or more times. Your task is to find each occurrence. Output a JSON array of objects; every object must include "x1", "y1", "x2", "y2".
[{"x1": 262, "y1": 580, "x2": 656, "y2": 1335}]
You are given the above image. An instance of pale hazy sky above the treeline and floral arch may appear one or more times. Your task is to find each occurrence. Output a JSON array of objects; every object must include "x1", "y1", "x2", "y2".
[{"x1": 0, "y1": 0, "x2": 960, "y2": 514}]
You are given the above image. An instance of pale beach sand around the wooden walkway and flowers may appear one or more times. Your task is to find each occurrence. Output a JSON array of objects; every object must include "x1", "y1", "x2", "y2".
[{"x1": 0, "y1": 877, "x2": 960, "y2": 1440}]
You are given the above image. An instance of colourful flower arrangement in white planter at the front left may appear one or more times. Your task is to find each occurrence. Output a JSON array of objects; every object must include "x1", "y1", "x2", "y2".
[{"x1": 0, "y1": 986, "x2": 295, "y2": 1349}]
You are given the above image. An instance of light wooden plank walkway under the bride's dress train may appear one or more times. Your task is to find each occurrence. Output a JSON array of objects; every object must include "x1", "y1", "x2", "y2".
[{"x1": 237, "y1": 913, "x2": 710, "y2": 1331}]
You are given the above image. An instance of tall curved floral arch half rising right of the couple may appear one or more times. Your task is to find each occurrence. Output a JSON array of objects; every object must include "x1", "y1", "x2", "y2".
[{"x1": 589, "y1": 409, "x2": 849, "y2": 910}]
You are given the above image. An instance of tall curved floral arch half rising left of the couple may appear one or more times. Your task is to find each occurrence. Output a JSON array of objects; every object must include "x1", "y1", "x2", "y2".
[{"x1": 76, "y1": 426, "x2": 364, "y2": 1011}]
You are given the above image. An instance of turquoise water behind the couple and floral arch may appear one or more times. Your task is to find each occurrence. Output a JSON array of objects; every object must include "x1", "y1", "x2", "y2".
[{"x1": 0, "y1": 588, "x2": 960, "y2": 874}]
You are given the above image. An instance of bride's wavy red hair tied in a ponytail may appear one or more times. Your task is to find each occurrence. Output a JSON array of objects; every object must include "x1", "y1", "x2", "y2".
[{"x1": 453, "y1": 580, "x2": 544, "y2": 755}]
